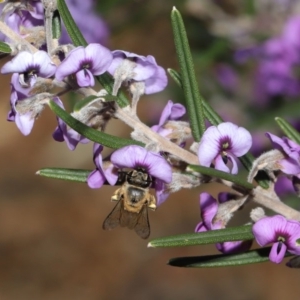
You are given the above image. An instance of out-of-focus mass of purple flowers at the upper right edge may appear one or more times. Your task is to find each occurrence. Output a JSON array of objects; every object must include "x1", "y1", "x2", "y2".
[{"x1": 235, "y1": 15, "x2": 300, "y2": 106}]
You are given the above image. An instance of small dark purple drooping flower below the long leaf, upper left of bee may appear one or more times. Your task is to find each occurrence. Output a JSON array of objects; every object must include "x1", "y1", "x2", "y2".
[{"x1": 52, "y1": 101, "x2": 90, "y2": 151}]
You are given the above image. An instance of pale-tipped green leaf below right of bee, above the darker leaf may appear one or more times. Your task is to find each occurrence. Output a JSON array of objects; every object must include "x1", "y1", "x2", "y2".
[{"x1": 148, "y1": 225, "x2": 253, "y2": 248}]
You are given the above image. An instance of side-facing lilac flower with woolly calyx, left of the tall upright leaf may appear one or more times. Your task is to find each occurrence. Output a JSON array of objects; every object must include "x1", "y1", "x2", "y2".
[{"x1": 108, "y1": 50, "x2": 168, "y2": 94}]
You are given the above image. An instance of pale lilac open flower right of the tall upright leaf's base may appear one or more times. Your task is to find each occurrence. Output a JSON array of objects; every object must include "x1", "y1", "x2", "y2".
[{"x1": 198, "y1": 122, "x2": 252, "y2": 174}]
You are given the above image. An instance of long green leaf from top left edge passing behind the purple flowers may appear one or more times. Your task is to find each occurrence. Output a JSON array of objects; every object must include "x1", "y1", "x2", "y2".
[{"x1": 57, "y1": 0, "x2": 129, "y2": 107}]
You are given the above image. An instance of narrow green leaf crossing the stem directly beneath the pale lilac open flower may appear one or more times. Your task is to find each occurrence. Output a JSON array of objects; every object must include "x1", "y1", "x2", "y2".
[{"x1": 187, "y1": 165, "x2": 254, "y2": 190}]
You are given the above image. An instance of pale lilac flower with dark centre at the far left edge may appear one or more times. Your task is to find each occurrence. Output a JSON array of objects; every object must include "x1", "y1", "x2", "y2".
[{"x1": 1, "y1": 51, "x2": 56, "y2": 88}]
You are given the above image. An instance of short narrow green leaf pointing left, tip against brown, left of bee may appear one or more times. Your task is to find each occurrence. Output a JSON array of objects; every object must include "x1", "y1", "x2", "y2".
[{"x1": 36, "y1": 168, "x2": 92, "y2": 182}]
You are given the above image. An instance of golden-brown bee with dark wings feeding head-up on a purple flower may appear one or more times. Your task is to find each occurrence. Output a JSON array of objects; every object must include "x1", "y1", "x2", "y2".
[{"x1": 102, "y1": 168, "x2": 156, "y2": 239}]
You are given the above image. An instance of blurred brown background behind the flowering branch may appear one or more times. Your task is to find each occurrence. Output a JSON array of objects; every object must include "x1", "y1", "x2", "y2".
[{"x1": 0, "y1": 1, "x2": 300, "y2": 300}]
